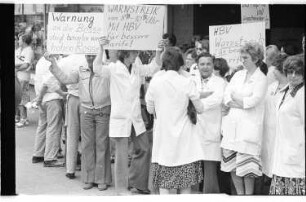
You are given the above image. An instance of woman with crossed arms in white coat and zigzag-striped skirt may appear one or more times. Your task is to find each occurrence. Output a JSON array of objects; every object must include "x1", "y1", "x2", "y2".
[{"x1": 221, "y1": 43, "x2": 267, "y2": 195}]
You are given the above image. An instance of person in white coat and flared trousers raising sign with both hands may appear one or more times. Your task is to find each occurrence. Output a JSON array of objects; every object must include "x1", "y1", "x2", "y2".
[{"x1": 94, "y1": 37, "x2": 164, "y2": 194}]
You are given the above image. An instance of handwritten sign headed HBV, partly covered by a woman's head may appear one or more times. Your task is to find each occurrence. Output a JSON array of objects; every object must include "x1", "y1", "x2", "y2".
[{"x1": 209, "y1": 22, "x2": 266, "y2": 69}]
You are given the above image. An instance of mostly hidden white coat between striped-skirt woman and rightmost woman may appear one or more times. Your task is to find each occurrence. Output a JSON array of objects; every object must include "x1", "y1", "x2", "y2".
[{"x1": 261, "y1": 81, "x2": 282, "y2": 178}]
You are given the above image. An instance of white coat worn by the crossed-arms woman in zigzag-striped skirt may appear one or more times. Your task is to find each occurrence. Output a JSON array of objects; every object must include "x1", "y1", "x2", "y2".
[{"x1": 221, "y1": 68, "x2": 267, "y2": 155}]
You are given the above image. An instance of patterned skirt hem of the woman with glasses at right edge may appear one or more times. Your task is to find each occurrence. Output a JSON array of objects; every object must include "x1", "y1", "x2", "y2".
[{"x1": 269, "y1": 175, "x2": 305, "y2": 195}]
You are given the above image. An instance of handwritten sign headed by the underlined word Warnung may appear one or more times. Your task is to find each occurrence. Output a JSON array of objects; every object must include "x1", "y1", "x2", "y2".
[{"x1": 47, "y1": 12, "x2": 103, "y2": 54}]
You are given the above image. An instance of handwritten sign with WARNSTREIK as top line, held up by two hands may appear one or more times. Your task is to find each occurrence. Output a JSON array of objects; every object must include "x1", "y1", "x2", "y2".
[{"x1": 104, "y1": 5, "x2": 165, "y2": 50}]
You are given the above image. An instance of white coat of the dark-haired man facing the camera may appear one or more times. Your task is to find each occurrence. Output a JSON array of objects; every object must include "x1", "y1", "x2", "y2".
[{"x1": 197, "y1": 74, "x2": 226, "y2": 161}]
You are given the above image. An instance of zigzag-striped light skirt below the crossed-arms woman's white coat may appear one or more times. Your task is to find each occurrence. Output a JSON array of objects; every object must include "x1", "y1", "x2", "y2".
[{"x1": 221, "y1": 149, "x2": 262, "y2": 177}]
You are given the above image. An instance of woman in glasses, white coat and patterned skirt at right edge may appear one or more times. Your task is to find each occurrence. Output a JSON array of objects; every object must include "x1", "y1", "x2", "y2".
[{"x1": 270, "y1": 56, "x2": 305, "y2": 195}]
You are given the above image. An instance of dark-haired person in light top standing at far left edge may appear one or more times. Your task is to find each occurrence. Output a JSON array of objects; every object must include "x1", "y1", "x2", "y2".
[{"x1": 15, "y1": 34, "x2": 34, "y2": 127}]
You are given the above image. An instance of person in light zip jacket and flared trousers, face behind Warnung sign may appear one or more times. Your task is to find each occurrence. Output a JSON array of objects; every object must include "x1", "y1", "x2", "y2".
[{"x1": 44, "y1": 49, "x2": 112, "y2": 191}]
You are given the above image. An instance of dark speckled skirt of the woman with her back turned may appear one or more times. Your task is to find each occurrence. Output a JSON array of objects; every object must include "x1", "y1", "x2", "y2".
[{"x1": 151, "y1": 161, "x2": 203, "y2": 189}]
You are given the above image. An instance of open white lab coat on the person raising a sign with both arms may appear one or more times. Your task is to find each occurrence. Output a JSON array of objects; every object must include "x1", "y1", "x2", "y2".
[{"x1": 94, "y1": 60, "x2": 160, "y2": 137}]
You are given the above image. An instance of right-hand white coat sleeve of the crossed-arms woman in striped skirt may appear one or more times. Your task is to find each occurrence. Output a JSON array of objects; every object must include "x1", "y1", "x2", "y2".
[{"x1": 243, "y1": 76, "x2": 268, "y2": 109}]
